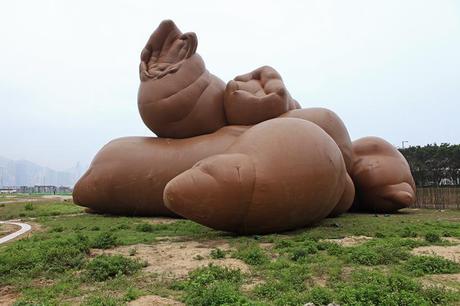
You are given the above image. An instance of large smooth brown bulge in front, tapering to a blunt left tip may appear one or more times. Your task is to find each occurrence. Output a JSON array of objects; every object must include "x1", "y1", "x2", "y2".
[{"x1": 164, "y1": 118, "x2": 347, "y2": 234}]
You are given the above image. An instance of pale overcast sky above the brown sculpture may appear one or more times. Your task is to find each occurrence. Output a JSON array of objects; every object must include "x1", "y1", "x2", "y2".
[{"x1": 0, "y1": 0, "x2": 460, "y2": 170}]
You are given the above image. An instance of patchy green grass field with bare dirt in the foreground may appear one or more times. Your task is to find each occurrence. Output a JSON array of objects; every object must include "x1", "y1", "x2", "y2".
[{"x1": 0, "y1": 200, "x2": 460, "y2": 305}]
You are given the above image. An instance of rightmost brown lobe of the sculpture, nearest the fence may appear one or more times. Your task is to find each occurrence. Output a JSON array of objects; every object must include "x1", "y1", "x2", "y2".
[{"x1": 352, "y1": 137, "x2": 415, "y2": 213}]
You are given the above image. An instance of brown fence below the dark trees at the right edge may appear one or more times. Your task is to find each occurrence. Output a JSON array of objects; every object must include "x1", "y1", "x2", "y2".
[{"x1": 413, "y1": 187, "x2": 460, "y2": 209}]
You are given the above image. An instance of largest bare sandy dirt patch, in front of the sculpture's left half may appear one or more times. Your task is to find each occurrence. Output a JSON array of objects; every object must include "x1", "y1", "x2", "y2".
[{"x1": 92, "y1": 241, "x2": 249, "y2": 278}]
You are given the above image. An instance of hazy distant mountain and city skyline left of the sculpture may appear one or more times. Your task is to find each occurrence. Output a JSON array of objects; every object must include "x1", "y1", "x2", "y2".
[{"x1": 0, "y1": 157, "x2": 82, "y2": 187}]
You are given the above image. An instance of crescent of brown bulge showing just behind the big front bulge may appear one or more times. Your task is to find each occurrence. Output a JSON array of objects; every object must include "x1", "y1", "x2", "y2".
[{"x1": 280, "y1": 107, "x2": 353, "y2": 173}]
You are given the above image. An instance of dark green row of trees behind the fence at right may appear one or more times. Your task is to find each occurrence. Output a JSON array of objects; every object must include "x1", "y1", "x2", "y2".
[{"x1": 399, "y1": 143, "x2": 460, "y2": 186}]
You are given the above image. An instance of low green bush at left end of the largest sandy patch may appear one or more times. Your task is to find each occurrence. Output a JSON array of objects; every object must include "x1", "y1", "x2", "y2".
[{"x1": 86, "y1": 255, "x2": 143, "y2": 281}]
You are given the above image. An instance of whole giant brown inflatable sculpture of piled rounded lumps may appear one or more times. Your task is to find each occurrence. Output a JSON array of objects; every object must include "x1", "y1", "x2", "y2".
[{"x1": 73, "y1": 20, "x2": 415, "y2": 234}]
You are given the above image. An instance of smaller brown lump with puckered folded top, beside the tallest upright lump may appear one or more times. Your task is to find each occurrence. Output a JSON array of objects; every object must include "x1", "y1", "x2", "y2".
[{"x1": 224, "y1": 66, "x2": 300, "y2": 125}]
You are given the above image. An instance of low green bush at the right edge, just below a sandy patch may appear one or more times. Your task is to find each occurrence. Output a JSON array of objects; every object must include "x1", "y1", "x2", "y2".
[{"x1": 404, "y1": 256, "x2": 460, "y2": 276}]
